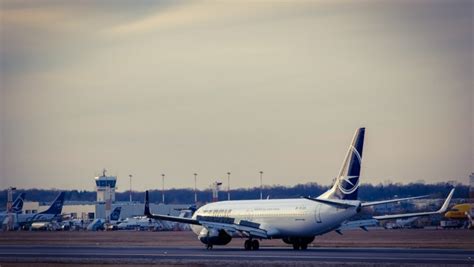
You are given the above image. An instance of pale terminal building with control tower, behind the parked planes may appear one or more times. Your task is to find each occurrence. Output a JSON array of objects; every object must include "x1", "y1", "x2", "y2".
[{"x1": 23, "y1": 170, "x2": 190, "y2": 220}]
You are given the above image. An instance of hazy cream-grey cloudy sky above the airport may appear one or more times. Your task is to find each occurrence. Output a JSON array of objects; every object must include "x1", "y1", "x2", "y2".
[{"x1": 0, "y1": 0, "x2": 474, "y2": 191}]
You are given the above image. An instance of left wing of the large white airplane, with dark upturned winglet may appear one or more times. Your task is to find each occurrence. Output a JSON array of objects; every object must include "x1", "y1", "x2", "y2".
[{"x1": 145, "y1": 191, "x2": 268, "y2": 238}]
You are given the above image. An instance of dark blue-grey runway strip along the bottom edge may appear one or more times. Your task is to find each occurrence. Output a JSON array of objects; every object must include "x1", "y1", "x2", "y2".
[{"x1": 0, "y1": 245, "x2": 474, "y2": 266}]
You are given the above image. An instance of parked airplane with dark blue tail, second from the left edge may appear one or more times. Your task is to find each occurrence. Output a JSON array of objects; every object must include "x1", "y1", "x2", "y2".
[{"x1": 16, "y1": 192, "x2": 65, "y2": 227}]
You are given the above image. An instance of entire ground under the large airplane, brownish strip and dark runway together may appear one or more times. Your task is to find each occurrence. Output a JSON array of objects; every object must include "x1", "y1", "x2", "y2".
[{"x1": 0, "y1": 229, "x2": 474, "y2": 267}]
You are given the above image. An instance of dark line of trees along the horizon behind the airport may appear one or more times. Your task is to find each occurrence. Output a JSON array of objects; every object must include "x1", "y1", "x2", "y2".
[{"x1": 0, "y1": 182, "x2": 469, "y2": 207}]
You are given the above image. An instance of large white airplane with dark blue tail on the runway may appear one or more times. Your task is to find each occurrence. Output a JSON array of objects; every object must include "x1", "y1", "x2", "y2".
[{"x1": 144, "y1": 128, "x2": 454, "y2": 250}]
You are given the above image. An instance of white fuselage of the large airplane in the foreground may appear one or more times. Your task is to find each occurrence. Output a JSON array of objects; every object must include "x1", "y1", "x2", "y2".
[{"x1": 191, "y1": 198, "x2": 359, "y2": 238}]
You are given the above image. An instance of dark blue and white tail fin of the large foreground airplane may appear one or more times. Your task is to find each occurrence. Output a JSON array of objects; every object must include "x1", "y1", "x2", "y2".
[{"x1": 319, "y1": 128, "x2": 365, "y2": 200}]
